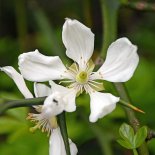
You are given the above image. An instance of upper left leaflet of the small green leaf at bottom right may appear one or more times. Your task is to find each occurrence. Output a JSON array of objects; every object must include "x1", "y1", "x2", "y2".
[{"x1": 119, "y1": 123, "x2": 134, "y2": 144}]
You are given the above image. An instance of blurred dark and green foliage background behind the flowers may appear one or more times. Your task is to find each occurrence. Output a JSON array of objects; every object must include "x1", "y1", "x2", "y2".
[{"x1": 0, "y1": 0, "x2": 155, "y2": 155}]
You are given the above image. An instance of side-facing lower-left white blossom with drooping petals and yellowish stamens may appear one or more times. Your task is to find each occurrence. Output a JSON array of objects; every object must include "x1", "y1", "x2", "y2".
[{"x1": 0, "y1": 66, "x2": 78, "y2": 155}]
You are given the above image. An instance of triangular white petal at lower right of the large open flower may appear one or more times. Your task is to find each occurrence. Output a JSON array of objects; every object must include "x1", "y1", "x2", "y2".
[{"x1": 89, "y1": 92, "x2": 119, "y2": 122}]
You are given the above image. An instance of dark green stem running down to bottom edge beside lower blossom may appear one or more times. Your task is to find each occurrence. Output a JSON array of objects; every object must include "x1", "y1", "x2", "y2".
[{"x1": 57, "y1": 112, "x2": 71, "y2": 155}]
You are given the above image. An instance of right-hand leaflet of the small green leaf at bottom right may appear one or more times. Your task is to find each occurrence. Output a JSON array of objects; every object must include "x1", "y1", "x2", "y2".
[{"x1": 134, "y1": 126, "x2": 147, "y2": 148}]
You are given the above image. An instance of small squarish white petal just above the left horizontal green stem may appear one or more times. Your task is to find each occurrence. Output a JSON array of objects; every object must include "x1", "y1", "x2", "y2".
[{"x1": 34, "y1": 82, "x2": 51, "y2": 97}]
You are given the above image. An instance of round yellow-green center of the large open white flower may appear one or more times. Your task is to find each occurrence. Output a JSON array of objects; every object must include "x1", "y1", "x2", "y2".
[{"x1": 76, "y1": 71, "x2": 88, "y2": 84}]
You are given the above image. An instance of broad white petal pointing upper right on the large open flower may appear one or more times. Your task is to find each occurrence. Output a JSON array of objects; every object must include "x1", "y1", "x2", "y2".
[{"x1": 94, "y1": 38, "x2": 139, "y2": 82}]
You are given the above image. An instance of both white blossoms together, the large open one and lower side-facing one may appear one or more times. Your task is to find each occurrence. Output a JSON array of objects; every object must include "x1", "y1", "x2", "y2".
[{"x1": 1, "y1": 19, "x2": 139, "y2": 155}]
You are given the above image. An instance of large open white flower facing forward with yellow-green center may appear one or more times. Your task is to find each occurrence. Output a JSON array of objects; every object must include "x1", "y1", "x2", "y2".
[{"x1": 19, "y1": 19, "x2": 139, "y2": 122}]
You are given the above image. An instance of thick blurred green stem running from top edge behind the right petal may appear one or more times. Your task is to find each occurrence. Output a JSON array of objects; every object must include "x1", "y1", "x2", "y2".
[{"x1": 101, "y1": 0, "x2": 149, "y2": 155}]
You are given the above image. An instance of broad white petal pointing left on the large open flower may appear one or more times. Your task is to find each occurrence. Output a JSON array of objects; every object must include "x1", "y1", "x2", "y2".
[{"x1": 18, "y1": 50, "x2": 66, "y2": 82}]
